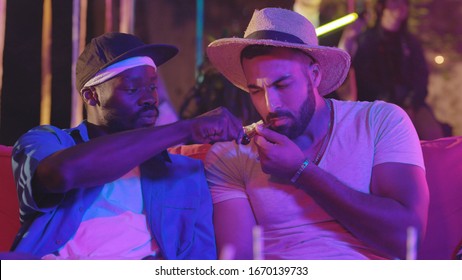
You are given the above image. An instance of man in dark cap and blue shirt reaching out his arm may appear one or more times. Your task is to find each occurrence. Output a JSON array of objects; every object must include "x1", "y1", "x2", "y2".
[{"x1": 10, "y1": 33, "x2": 243, "y2": 259}]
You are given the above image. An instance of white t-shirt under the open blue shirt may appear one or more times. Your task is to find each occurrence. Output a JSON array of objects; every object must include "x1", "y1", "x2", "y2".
[{"x1": 43, "y1": 167, "x2": 159, "y2": 260}]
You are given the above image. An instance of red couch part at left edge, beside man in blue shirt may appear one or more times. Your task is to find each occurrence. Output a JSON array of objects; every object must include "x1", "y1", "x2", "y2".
[{"x1": 0, "y1": 145, "x2": 20, "y2": 252}]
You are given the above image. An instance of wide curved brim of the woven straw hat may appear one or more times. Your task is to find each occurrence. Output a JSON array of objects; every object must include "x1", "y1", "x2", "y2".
[{"x1": 207, "y1": 38, "x2": 351, "y2": 96}]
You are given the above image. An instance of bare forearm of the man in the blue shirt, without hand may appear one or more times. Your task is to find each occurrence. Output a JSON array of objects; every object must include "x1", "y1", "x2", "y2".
[{"x1": 35, "y1": 121, "x2": 190, "y2": 193}]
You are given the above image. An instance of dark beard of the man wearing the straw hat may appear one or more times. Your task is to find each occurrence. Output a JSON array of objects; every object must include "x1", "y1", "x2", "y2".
[{"x1": 266, "y1": 98, "x2": 315, "y2": 140}]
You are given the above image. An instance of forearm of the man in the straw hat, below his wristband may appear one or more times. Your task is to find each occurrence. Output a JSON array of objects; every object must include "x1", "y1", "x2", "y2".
[{"x1": 298, "y1": 165, "x2": 424, "y2": 258}]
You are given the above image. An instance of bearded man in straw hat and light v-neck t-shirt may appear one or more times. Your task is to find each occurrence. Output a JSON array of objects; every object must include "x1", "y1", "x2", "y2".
[{"x1": 206, "y1": 8, "x2": 429, "y2": 259}]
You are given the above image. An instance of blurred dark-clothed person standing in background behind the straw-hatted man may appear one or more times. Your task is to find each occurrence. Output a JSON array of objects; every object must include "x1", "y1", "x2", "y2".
[{"x1": 339, "y1": 0, "x2": 445, "y2": 140}]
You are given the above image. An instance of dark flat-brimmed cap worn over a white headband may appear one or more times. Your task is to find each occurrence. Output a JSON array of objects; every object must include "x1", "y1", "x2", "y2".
[{"x1": 76, "y1": 32, "x2": 178, "y2": 92}]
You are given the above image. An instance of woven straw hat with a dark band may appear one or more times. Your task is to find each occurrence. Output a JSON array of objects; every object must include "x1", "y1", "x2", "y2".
[{"x1": 207, "y1": 8, "x2": 350, "y2": 95}]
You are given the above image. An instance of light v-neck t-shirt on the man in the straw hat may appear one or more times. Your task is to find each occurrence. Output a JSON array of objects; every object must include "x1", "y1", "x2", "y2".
[{"x1": 206, "y1": 100, "x2": 424, "y2": 259}]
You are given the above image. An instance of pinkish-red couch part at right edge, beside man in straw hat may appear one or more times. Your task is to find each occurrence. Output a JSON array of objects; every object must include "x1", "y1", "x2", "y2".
[{"x1": 419, "y1": 136, "x2": 462, "y2": 259}]
